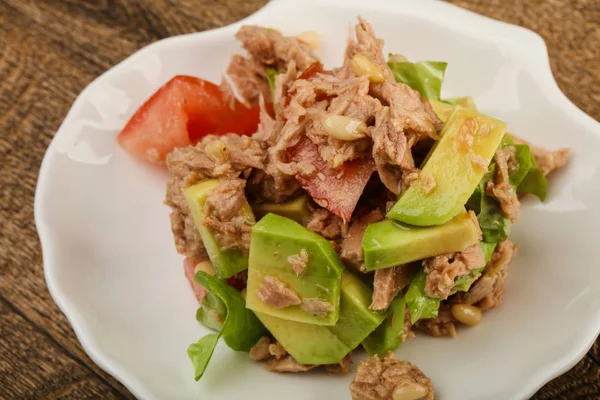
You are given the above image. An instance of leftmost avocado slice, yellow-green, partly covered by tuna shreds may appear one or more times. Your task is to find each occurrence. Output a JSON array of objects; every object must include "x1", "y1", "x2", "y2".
[{"x1": 183, "y1": 179, "x2": 255, "y2": 279}]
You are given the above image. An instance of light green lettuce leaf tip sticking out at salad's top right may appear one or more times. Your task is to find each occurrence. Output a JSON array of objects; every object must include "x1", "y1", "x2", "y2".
[{"x1": 388, "y1": 61, "x2": 448, "y2": 99}]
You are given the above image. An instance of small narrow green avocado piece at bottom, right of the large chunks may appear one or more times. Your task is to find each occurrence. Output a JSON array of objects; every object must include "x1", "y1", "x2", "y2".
[{"x1": 362, "y1": 295, "x2": 406, "y2": 356}]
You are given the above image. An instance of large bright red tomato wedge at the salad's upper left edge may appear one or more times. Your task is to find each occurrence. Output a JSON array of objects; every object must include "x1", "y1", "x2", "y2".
[{"x1": 117, "y1": 75, "x2": 260, "y2": 164}]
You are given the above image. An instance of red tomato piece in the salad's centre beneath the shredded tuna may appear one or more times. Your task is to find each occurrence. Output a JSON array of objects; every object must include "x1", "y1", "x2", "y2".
[{"x1": 288, "y1": 137, "x2": 374, "y2": 221}]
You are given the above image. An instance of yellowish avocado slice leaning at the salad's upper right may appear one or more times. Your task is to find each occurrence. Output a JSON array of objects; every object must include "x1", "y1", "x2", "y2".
[{"x1": 387, "y1": 106, "x2": 506, "y2": 226}]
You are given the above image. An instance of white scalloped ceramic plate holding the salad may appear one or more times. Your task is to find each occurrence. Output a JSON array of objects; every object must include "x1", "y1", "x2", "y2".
[{"x1": 35, "y1": 0, "x2": 600, "y2": 400}]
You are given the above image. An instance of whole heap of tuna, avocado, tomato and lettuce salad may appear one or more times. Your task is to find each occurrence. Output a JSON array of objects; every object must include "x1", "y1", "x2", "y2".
[{"x1": 118, "y1": 18, "x2": 569, "y2": 400}]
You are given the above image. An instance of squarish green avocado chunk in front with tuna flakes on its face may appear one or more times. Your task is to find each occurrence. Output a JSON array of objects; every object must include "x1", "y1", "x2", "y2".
[{"x1": 246, "y1": 213, "x2": 344, "y2": 326}]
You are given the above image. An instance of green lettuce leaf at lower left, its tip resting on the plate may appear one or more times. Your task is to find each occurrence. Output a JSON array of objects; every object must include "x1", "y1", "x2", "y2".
[{"x1": 188, "y1": 271, "x2": 268, "y2": 380}]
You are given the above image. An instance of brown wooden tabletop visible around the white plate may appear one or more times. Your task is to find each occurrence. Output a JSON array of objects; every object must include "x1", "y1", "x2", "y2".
[{"x1": 0, "y1": 0, "x2": 600, "y2": 400}]
